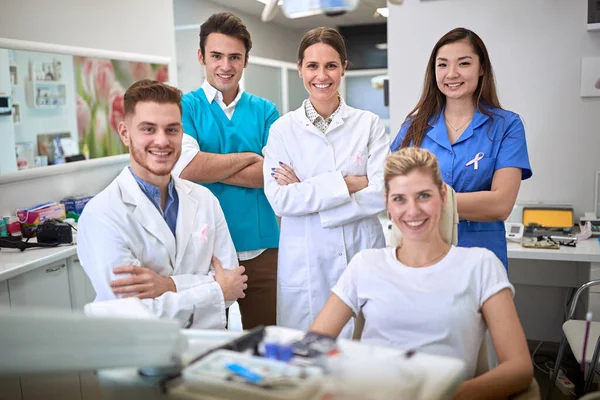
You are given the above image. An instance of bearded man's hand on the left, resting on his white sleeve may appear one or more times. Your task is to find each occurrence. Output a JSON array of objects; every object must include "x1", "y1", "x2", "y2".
[{"x1": 110, "y1": 265, "x2": 177, "y2": 299}]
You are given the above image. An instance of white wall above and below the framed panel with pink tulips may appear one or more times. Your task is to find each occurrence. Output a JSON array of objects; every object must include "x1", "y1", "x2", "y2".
[{"x1": 0, "y1": 0, "x2": 177, "y2": 215}]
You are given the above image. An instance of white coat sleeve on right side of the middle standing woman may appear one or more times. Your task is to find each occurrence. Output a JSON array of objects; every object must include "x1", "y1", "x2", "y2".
[{"x1": 319, "y1": 118, "x2": 390, "y2": 228}]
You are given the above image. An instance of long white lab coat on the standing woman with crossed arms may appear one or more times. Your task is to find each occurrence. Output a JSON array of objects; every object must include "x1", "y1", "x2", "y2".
[{"x1": 263, "y1": 100, "x2": 389, "y2": 337}]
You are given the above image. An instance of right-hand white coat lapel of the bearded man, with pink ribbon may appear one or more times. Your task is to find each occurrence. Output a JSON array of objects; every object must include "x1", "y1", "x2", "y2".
[{"x1": 173, "y1": 178, "x2": 199, "y2": 272}]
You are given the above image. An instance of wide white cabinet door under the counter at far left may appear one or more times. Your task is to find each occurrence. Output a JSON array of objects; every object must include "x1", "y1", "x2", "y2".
[{"x1": 8, "y1": 260, "x2": 71, "y2": 310}]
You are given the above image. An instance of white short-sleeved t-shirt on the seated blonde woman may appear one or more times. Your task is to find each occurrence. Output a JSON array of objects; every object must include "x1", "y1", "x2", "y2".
[{"x1": 332, "y1": 246, "x2": 514, "y2": 377}]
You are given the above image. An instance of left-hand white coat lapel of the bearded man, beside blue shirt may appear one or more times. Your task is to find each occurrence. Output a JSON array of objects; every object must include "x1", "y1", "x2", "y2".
[{"x1": 117, "y1": 167, "x2": 176, "y2": 268}]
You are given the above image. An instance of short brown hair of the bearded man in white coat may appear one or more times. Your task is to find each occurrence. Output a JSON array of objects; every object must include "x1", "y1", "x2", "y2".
[{"x1": 123, "y1": 79, "x2": 182, "y2": 116}]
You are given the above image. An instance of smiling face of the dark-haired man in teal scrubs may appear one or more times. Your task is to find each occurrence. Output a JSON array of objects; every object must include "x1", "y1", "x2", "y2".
[{"x1": 198, "y1": 32, "x2": 248, "y2": 96}]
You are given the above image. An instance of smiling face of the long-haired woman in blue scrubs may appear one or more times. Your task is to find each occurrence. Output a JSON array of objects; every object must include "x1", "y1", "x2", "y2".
[{"x1": 435, "y1": 40, "x2": 483, "y2": 99}]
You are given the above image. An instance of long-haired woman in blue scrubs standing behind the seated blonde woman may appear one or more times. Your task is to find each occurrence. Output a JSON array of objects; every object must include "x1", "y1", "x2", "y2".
[{"x1": 391, "y1": 28, "x2": 532, "y2": 268}]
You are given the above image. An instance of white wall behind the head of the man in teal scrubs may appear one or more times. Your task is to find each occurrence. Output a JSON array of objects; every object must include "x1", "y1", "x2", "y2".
[{"x1": 174, "y1": 0, "x2": 305, "y2": 92}]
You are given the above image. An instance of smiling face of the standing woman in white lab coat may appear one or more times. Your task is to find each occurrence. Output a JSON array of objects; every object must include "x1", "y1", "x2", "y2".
[{"x1": 298, "y1": 43, "x2": 348, "y2": 103}]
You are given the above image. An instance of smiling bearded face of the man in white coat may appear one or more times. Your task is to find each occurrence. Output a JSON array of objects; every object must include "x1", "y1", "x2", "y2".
[{"x1": 119, "y1": 101, "x2": 183, "y2": 186}]
